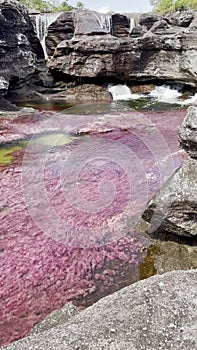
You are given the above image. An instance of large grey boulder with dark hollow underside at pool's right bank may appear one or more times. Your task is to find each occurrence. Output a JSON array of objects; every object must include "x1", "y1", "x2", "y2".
[{"x1": 143, "y1": 159, "x2": 197, "y2": 237}]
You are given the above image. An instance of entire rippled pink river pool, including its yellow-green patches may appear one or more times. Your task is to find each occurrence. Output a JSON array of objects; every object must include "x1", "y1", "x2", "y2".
[{"x1": 0, "y1": 103, "x2": 195, "y2": 344}]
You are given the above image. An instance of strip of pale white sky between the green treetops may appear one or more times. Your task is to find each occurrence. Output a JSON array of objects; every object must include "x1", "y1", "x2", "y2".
[{"x1": 68, "y1": 0, "x2": 151, "y2": 13}]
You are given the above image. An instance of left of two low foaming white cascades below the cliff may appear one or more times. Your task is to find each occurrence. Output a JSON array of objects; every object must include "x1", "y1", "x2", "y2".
[{"x1": 108, "y1": 84, "x2": 143, "y2": 101}]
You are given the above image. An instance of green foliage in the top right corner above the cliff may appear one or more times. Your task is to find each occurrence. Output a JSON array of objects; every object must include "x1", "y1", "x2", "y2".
[{"x1": 150, "y1": 0, "x2": 197, "y2": 13}]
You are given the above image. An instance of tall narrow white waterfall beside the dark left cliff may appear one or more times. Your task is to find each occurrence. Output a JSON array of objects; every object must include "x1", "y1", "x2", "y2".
[{"x1": 35, "y1": 13, "x2": 61, "y2": 59}]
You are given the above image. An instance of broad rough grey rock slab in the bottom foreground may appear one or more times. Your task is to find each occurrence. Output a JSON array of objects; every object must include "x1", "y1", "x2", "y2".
[{"x1": 2, "y1": 270, "x2": 197, "y2": 350}]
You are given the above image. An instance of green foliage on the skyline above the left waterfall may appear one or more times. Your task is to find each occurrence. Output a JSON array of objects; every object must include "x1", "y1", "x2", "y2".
[{"x1": 18, "y1": 0, "x2": 84, "y2": 12}]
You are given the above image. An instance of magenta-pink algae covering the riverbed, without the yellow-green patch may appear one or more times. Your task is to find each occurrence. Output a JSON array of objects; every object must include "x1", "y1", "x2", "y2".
[{"x1": 0, "y1": 111, "x2": 185, "y2": 345}]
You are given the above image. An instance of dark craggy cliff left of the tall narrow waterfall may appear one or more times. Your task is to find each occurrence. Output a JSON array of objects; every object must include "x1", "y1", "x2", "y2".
[{"x1": 0, "y1": 0, "x2": 43, "y2": 108}]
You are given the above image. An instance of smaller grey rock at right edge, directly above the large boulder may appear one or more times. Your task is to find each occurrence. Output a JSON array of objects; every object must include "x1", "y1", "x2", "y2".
[{"x1": 179, "y1": 107, "x2": 197, "y2": 157}]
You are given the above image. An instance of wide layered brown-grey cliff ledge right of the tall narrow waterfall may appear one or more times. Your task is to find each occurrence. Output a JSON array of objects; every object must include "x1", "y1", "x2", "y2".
[{"x1": 47, "y1": 11, "x2": 197, "y2": 86}]
